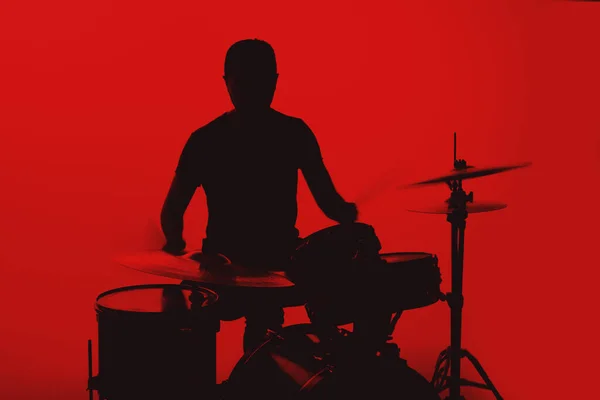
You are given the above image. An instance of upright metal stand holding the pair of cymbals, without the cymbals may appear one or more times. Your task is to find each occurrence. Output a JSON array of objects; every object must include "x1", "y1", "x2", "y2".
[{"x1": 432, "y1": 133, "x2": 502, "y2": 400}]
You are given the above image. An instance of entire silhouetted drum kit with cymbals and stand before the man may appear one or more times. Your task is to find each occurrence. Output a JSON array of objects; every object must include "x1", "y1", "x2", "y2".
[{"x1": 88, "y1": 134, "x2": 530, "y2": 400}]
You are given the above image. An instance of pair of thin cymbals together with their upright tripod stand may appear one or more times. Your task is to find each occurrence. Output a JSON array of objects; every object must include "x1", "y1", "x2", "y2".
[{"x1": 411, "y1": 133, "x2": 531, "y2": 400}]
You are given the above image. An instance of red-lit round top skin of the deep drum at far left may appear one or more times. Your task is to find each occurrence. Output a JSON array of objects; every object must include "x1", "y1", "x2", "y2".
[{"x1": 96, "y1": 284, "x2": 218, "y2": 315}]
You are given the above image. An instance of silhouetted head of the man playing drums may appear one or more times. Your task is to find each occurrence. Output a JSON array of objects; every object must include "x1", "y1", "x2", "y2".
[{"x1": 223, "y1": 39, "x2": 278, "y2": 111}]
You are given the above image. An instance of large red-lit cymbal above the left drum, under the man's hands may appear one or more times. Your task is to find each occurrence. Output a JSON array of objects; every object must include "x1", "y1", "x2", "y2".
[{"x1": 115, "y1": 250, "x2": 294, "y2": 288}]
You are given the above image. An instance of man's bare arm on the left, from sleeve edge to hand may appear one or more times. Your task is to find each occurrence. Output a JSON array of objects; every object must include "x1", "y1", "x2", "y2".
[{"x1": 160, "y1": 175, "x2": 196, "y2": 254}]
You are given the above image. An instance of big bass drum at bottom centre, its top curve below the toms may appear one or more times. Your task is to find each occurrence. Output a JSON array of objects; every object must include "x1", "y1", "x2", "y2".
[{"x1": 222, "y1": 324, "x2": 440, "y2": 400}]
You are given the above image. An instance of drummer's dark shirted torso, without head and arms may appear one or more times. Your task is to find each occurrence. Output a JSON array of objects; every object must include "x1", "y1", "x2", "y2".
[{"x1": 177, "y1": 111, "x2": 307, "y2": 268}]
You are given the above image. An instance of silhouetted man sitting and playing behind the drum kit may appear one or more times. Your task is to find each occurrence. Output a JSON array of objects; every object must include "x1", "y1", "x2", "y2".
[{"x1": 161, "y1": 39, "x2": 357, "y2": 351}]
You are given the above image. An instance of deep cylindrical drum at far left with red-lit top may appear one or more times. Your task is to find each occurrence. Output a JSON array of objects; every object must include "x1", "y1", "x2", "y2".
[{"x1": 90, "y1": 284, "x2": 219, "y2": 400}]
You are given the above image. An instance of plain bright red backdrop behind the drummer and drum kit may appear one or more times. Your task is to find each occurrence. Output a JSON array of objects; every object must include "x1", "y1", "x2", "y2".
[{"x1": 0, "y1": 0, "x2": 600, "y2": 399}]
